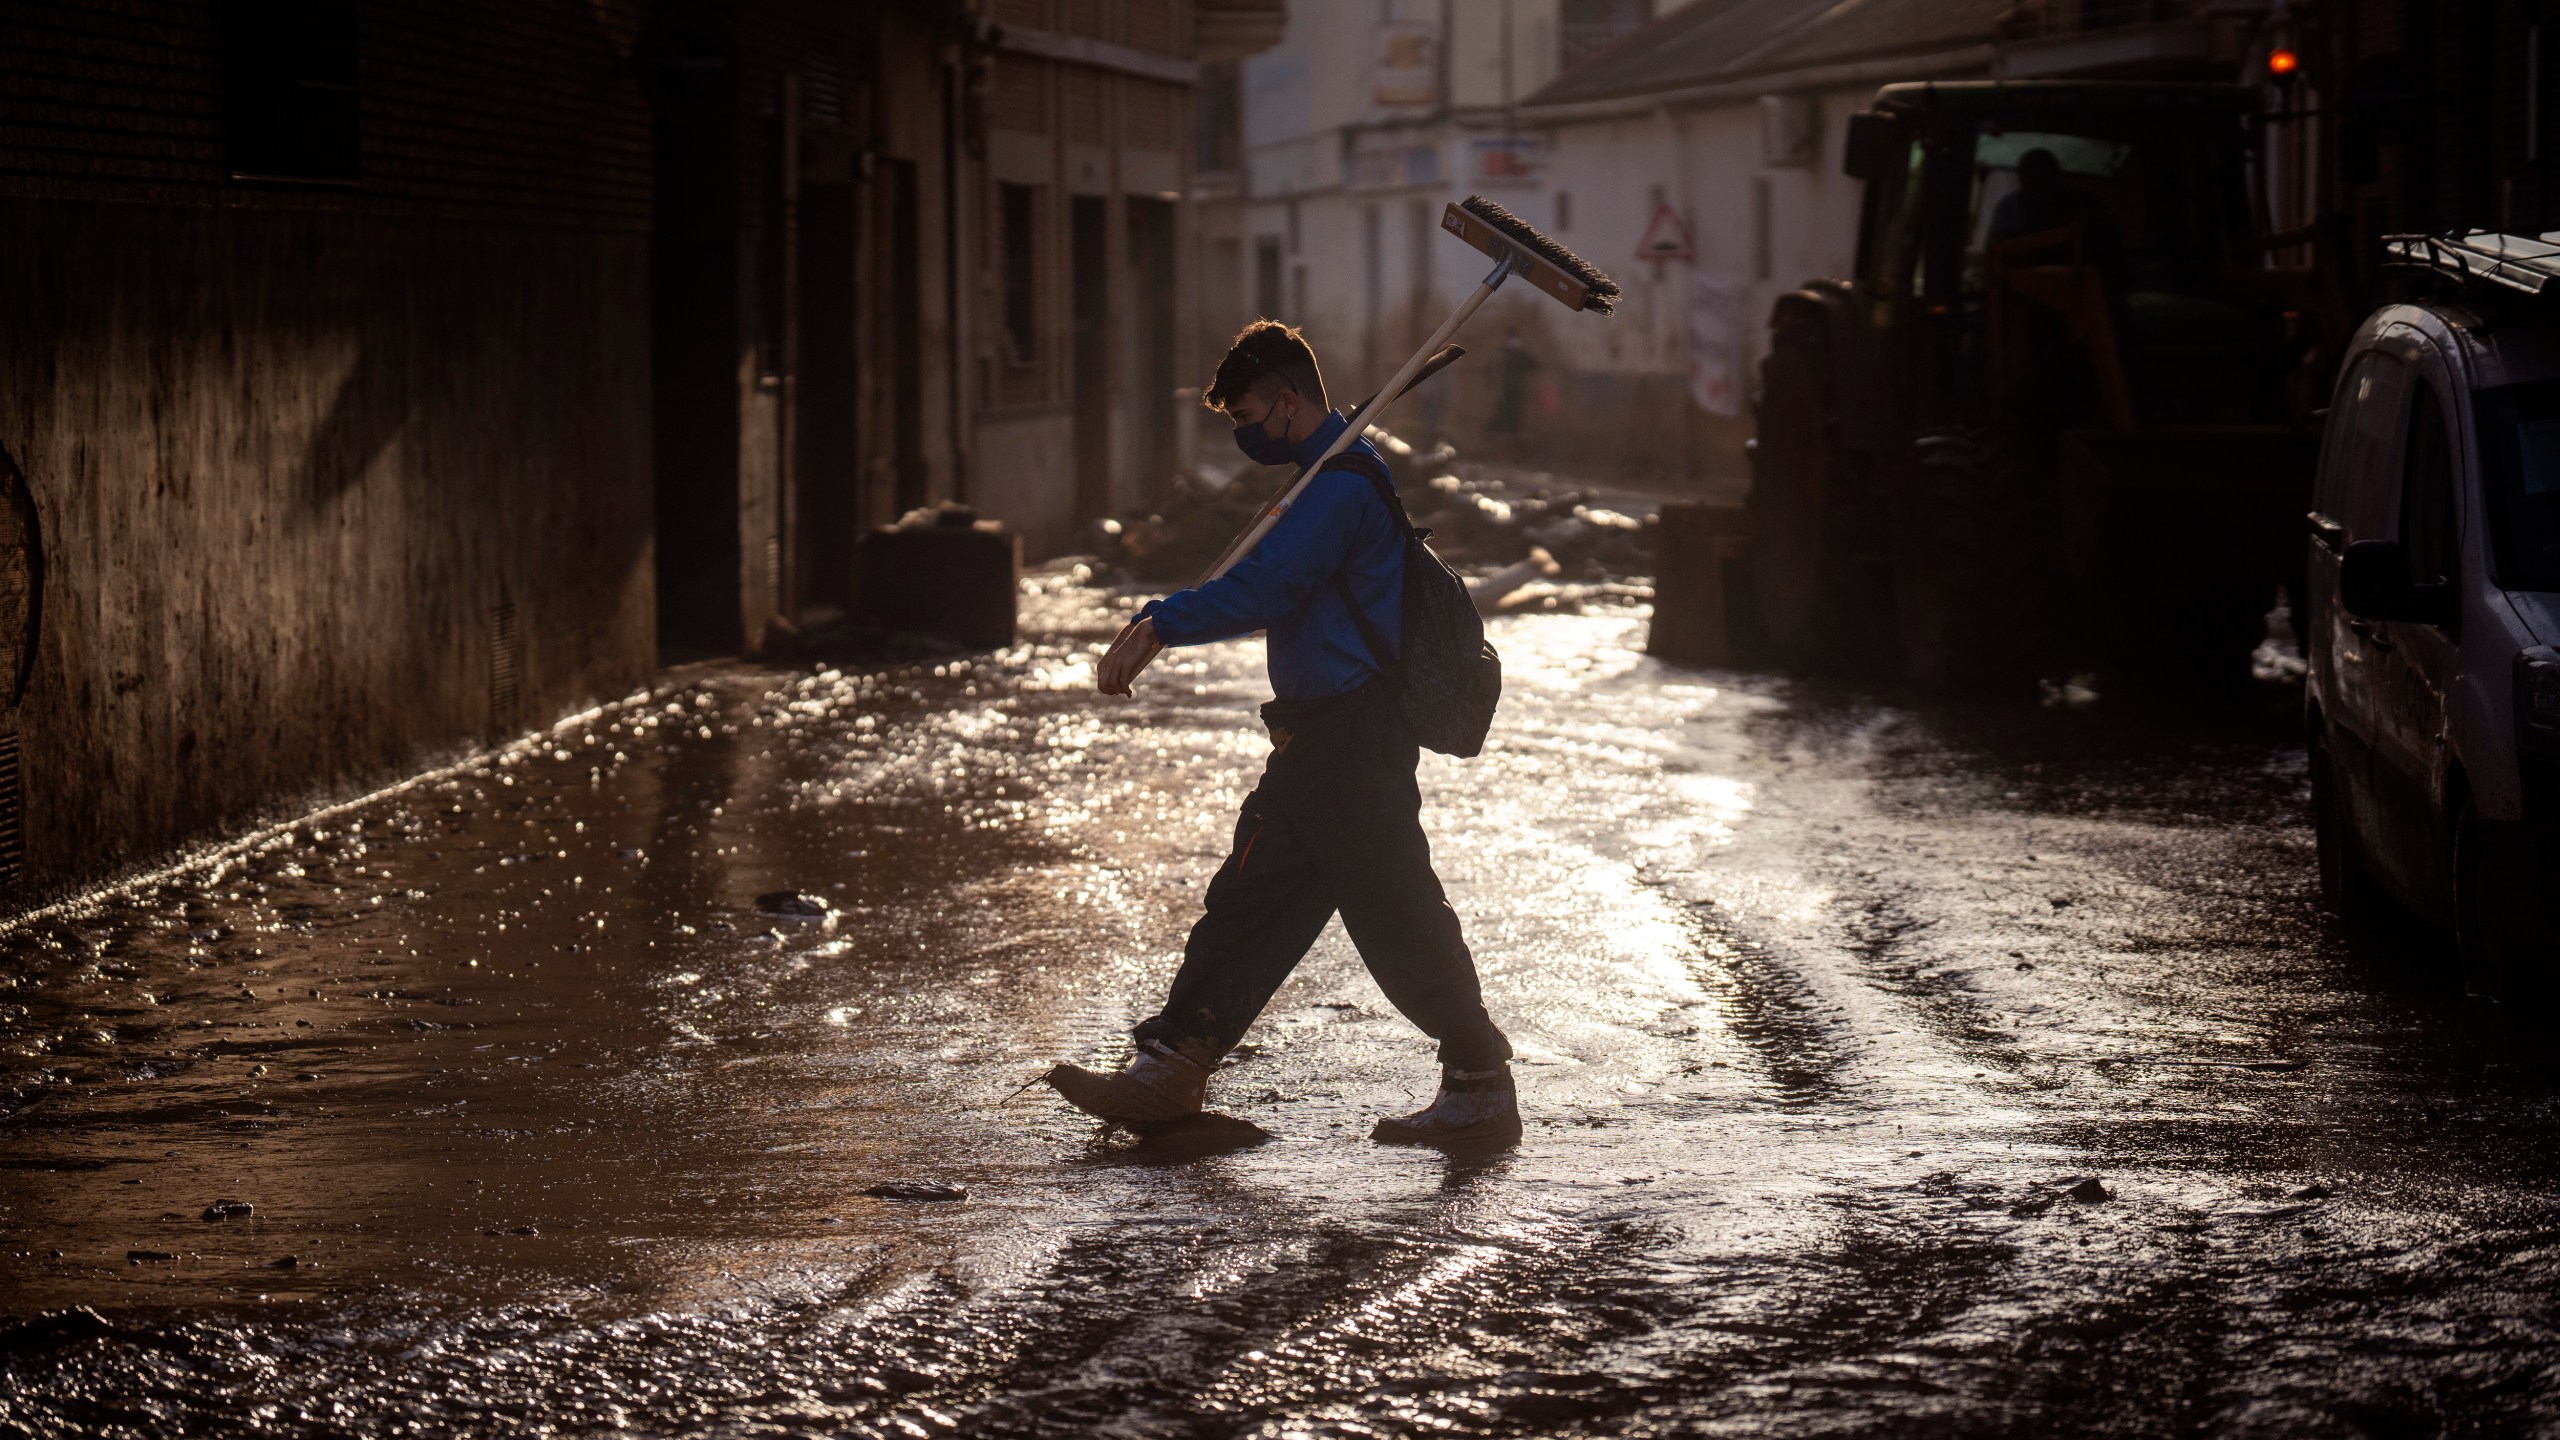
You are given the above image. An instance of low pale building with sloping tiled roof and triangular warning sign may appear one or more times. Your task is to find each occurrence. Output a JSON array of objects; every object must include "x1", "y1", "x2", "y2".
[{"x1": 1521, "y1": 0, "x2": 2015, "y2": 495}]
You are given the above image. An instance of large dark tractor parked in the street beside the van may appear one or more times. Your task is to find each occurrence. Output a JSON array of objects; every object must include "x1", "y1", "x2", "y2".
[{"x1": 1748, "y1": 82, "x2": 2348, "y2": 689}]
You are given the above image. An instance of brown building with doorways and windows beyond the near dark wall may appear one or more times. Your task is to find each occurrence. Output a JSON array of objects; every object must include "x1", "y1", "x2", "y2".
[{"x1": 653, "y1": 0, "x2": 1285, "y2": 638}]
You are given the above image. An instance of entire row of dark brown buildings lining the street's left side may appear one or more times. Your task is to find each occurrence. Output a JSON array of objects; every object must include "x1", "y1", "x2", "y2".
[{"x1": 0, "y1": 0, "x2": 1249, "y2": 902}]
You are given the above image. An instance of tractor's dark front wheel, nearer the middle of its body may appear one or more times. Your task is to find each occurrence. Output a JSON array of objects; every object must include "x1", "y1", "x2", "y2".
[{"x1": 1894, "y1": 430, "x2": 2061, "y2": 692}]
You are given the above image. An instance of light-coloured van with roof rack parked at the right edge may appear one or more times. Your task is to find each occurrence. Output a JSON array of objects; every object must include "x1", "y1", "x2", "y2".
[{"x1": 2301, "y1": 233, "x2": 2560, "y2": 997}]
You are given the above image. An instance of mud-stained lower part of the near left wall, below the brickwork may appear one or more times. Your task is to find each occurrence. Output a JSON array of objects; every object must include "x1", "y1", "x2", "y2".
[{"x1": 0, "y1": 202, "x2": 653, "y2": 887}]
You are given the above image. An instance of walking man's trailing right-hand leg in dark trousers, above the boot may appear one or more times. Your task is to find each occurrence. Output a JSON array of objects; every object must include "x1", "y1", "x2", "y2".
[{"x1": 1288, "y1": 702, "x2": 1510, "y2": 1071}]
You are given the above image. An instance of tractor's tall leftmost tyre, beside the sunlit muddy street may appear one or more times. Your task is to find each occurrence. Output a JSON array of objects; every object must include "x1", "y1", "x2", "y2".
[{"x1": 1743, "y1": 315, "x2": 1884, "y2": 671}]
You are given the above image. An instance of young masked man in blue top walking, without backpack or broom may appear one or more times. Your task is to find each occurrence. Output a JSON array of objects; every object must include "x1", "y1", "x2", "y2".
[{"x1": 1047, "y1": 320, "x2": 1521, "y2": 1143}]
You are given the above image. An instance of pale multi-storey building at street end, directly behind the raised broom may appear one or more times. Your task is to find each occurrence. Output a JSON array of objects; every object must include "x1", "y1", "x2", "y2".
[{"x1": 1229, "y1": 0, "x2": 1651, "y2": 454}]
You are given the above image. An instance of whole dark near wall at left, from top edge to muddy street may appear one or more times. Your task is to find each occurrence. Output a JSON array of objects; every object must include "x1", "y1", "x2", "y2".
[{"x1": 0, "y1": 0, "x2": 655, "y2": 899}]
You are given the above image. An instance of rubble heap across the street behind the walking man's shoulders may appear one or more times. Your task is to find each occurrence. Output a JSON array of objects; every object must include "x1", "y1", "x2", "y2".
[{"x1": 1091, "y1": 425, "x2": 1654, "y2": 612}]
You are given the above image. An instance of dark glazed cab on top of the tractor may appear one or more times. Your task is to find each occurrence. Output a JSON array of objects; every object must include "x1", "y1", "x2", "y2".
[{"x1": 1848, "y1": 82, "x2": 2299, "y2": 430}]
